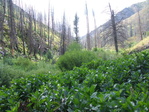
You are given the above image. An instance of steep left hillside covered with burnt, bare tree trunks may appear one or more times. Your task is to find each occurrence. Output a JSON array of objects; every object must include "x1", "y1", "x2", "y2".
[{"x1": 0, "y1": 0, "x2": 61, "y2": 57}]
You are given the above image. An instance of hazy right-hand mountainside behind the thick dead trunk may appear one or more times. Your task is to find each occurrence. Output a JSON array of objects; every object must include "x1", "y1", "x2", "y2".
[{"x1": 82, "y1": 2, "x2": 149, "y2": 48}]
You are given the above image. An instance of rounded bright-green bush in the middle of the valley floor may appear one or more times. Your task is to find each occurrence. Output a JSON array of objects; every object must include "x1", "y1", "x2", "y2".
[{"x1": 57, "y1": 51, "x2": 97, "y2": 71}]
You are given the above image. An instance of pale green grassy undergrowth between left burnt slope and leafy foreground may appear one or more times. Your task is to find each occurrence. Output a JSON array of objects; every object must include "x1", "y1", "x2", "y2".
[{"x1": 0, "y1": 57, "x2": 60, "y2": 87}]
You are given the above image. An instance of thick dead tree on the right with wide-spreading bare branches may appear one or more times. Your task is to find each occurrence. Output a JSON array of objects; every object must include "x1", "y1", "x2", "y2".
[{"x1": 100, "y1": 6, "x2": 128, "y2": 47}]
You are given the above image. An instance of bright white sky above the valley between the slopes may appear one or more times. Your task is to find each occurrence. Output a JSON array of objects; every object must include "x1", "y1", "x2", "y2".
[{"x1": 14, "y1": 0, "x2": 145, "y2": 36}]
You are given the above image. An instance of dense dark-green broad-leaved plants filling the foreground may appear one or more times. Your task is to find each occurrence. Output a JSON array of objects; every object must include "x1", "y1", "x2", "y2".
[{"x1": 0, "y1": 51, "x2": 149, "y2": 112}]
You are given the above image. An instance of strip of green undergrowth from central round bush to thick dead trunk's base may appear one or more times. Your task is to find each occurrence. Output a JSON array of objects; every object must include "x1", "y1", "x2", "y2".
[{"x1": 56, "y1": 48, "x2": 122, "y2": 71}]
